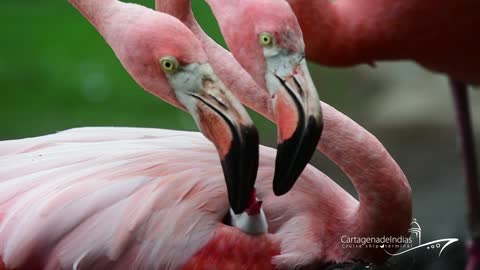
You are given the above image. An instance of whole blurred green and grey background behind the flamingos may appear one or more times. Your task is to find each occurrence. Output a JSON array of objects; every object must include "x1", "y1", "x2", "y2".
[{"x1": 0, "y1": 0, "x2": 480, "y2": 269}]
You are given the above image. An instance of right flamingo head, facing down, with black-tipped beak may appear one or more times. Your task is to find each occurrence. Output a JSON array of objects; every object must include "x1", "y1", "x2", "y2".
[{"x1": 210, "y1": 0, "x2": 323, "y2": 195}]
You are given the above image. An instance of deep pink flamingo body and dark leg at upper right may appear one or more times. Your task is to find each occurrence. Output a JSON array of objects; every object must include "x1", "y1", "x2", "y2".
[{"x1": 287, "y1": 0, "x2": 480, "y2": 269}]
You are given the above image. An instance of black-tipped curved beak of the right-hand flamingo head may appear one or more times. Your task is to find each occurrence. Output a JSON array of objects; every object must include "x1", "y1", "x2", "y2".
[{"x1": 266, "y1": 54, "x2": 323, "y2": 196}]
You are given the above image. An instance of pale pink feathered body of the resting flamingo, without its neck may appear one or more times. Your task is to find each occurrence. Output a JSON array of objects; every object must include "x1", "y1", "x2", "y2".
[{"x1": 0, "y1": 128, "x2": 402, "y2": 269}]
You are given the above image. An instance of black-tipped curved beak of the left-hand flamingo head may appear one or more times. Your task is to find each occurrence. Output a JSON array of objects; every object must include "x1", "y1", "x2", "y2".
[{"x1": 182, "y1": 64, "x2": 259, "y2": 214}]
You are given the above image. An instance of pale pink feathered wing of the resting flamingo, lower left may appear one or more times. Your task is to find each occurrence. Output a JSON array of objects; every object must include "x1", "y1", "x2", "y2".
[{"x1": 0, "y1": 128, "x2": 228, "y2": 269}]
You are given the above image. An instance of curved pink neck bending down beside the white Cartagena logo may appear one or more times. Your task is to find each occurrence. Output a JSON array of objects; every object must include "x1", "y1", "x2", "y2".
[{"x1": 317, "y1": 103, "x2": 412, "y2": 259}]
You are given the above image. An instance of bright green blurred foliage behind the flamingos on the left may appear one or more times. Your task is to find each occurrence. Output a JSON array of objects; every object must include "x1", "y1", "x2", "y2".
[{"x1": 0, "y1": 0, "x2": 354, "y2": 143}]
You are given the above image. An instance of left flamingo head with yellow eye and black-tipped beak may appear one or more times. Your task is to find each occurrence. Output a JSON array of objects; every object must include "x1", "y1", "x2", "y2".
[{"x1": 107, "y1": 11, "x2": 259, "y2": 214}]
